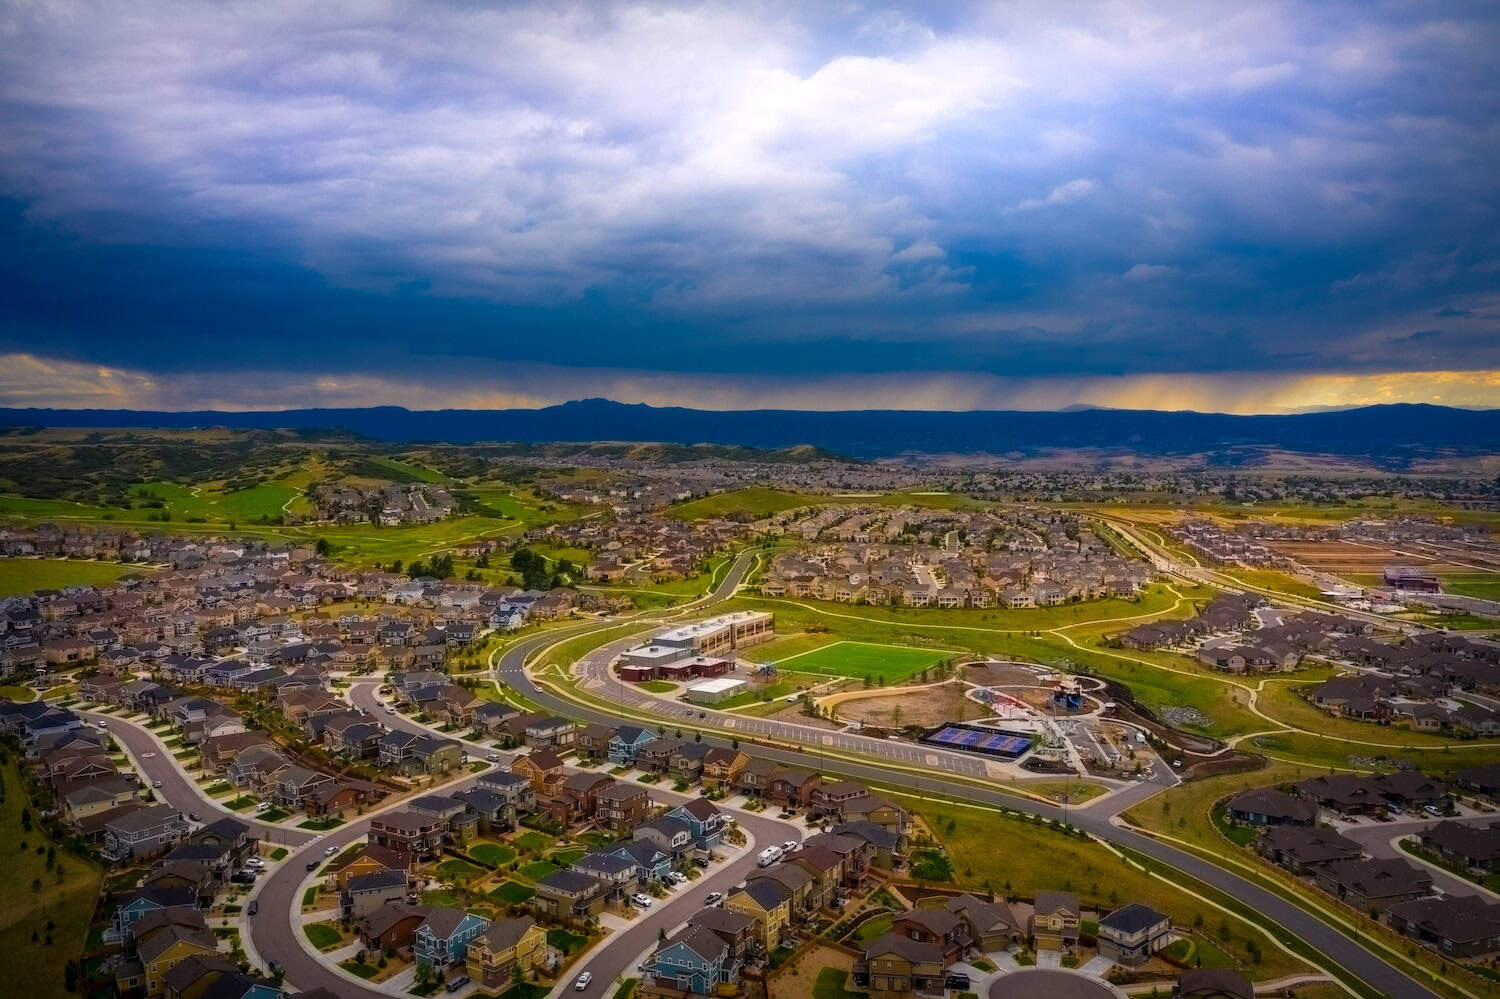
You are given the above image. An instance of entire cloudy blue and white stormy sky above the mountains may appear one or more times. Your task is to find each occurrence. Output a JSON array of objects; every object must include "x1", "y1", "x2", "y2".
[{"x1": 0, "y1": 0, "x2": 1500, "y2": 413}]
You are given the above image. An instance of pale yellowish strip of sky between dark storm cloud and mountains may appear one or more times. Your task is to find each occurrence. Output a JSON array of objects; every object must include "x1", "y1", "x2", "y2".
[{"x1": 0, "y1": 354, "x2": 1500, "y2": 414}]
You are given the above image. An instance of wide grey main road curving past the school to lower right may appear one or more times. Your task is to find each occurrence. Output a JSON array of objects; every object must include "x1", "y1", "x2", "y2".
[{"x1": 498, "y1": 557, "x2": 1436, "y2": 999}]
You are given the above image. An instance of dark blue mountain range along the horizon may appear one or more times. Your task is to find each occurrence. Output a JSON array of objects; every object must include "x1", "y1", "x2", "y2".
[{"x1": 0, "y1": 399, "x2": 1500, "y2": 465}]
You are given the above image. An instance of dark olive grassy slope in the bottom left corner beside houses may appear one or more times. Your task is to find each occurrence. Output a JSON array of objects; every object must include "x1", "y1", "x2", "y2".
[{"x1": 0, "y1": 759, "x2": 102, "y2": 996}]
